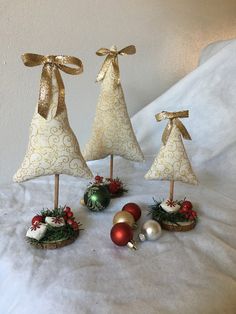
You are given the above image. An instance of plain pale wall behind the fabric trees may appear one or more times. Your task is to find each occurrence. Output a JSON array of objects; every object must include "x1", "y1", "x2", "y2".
[{"x1": 0, "y1": 0, "x2": 236, "y2": 182}]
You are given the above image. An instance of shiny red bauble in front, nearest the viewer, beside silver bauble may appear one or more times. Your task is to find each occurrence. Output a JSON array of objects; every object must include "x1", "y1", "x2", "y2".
[{"x1": 111, "y1": 222, "x2": 133, "y2": 246}]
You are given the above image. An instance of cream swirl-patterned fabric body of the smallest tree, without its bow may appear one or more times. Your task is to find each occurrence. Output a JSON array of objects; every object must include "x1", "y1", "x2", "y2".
[{"x1": 145, "y1": 125, "x2": 198, "y2": 184}]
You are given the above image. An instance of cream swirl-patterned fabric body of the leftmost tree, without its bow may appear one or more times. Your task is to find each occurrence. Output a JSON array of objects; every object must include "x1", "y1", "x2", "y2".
[{"x1": 13, "y1": 78, "x2": 92, "y2": 182}]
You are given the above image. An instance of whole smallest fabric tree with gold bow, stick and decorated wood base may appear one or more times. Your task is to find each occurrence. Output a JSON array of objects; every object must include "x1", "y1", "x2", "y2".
[{"x1": 145, "y1": 110, "x2": 198, "y2": 231}]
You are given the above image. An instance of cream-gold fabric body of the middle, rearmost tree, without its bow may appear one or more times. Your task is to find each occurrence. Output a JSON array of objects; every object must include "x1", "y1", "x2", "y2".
[{"x1": 83, "y1": 53, "x2": 144, "y2": 161}]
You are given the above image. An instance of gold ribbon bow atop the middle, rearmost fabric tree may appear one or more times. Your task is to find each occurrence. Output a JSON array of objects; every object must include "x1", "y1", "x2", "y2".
[{"x1": 96, "y1": 45, "x2": 136, "y2": 84}]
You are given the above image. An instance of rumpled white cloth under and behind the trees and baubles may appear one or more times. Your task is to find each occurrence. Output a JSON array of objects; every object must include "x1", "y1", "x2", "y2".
[{"x1": 0, "y1": 41, "x2": 236, "y2": 314}]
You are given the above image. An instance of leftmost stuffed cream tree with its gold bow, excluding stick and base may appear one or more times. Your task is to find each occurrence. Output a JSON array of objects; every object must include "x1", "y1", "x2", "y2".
[{"x1": 13, "y1": 54, "x2": 92, "y2": 182}]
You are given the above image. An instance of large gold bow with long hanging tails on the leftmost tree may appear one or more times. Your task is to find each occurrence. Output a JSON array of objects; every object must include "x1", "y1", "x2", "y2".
[{"x1": 22, "y1": 53, "x2": 83, "y2": 119}]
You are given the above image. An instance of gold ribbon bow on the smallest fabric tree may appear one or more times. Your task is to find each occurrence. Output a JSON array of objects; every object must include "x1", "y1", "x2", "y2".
[{"x1": 155, "y1": 110, "x2": 191, "y2": 145}]
